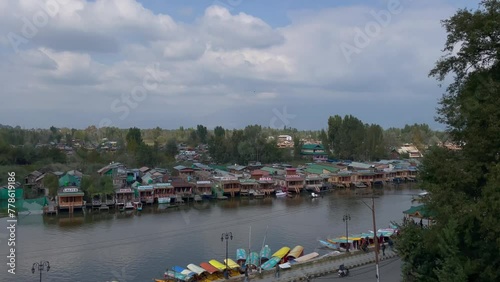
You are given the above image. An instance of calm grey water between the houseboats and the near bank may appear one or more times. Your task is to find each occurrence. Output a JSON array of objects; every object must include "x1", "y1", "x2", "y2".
[{"x1": 0, "y1": 185, "x2": 419, "y2": 282}]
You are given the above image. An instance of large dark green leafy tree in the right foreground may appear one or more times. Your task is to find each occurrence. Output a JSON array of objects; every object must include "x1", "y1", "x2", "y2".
[{"x1": 398, "y1": 0, "x2": 500, "y2": 281}]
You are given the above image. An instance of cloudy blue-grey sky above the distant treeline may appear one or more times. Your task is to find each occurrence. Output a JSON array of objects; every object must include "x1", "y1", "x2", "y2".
[{"x1": 0, "y1": 0, "x2": 484, "y2": 130}]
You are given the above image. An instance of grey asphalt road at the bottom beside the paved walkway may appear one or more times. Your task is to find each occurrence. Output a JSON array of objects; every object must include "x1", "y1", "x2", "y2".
[{"x1": 310, "y1": 257, "x2": 403, "y2": 282}]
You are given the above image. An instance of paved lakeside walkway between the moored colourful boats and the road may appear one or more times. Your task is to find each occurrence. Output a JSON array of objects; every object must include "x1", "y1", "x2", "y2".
[{"x1": 226, "y1": 248, "x2": 397, "y2": 282}]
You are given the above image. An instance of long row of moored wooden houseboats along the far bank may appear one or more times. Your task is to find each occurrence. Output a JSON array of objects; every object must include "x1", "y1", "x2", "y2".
[{"x1": 51, "y1": 164, "x2": 417, "y2": 211}]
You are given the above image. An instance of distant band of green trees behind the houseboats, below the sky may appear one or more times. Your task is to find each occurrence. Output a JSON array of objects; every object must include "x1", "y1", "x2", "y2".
[{"x1": 0, "y1": 115, "x2": 446, "y2": 170}]
